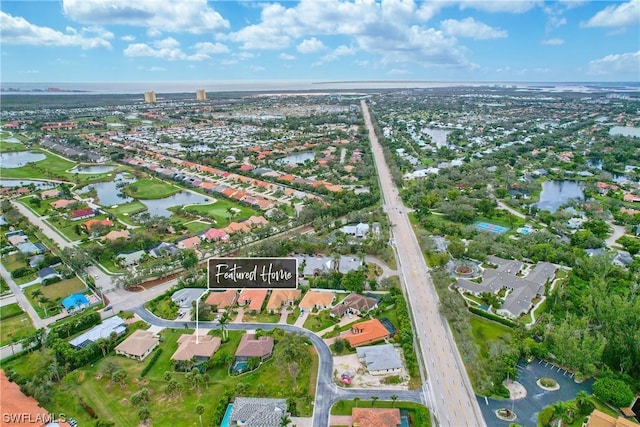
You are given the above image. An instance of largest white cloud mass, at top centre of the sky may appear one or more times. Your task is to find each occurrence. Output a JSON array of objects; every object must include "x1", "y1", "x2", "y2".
[{"x1": 224, "y1": 0, "x2": 470, "y2": 67}]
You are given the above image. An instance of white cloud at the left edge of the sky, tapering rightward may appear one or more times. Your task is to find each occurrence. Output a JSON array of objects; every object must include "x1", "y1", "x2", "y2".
[{"x1": 0, "y1": 11, "x2": 113, "y2": 49}]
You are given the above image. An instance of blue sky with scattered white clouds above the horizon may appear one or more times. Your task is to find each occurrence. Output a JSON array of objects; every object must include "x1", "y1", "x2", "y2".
[{"x1": 0, "y1": 0, "x2": 640, "y2": 82}]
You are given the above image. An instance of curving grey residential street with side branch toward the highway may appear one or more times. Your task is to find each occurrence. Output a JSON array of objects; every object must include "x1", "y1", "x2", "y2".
[{"x1": 133, "y1": 307, "x2": 424, "y2": 426}]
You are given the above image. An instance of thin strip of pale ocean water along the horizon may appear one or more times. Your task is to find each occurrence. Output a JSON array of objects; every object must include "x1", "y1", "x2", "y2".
[{"x1": 0, "y1": 80, "x2": 640, "y2": 95}]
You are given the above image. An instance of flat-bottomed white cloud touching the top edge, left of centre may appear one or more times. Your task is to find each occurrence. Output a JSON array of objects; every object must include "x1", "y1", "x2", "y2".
[{"x1": 62, "y1": 0, "x2": 229, "y2": 34}]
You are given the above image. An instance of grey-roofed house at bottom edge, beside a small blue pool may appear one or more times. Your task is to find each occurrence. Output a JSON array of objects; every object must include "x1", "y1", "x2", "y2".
[{"x1": 229, "y1": 397, "x2": 287, "y2": 427}]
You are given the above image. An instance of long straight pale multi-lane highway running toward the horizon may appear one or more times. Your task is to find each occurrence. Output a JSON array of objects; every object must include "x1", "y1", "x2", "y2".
[{"x1": 361, "y1": 100, "x2": 486, "y2": 427}]
